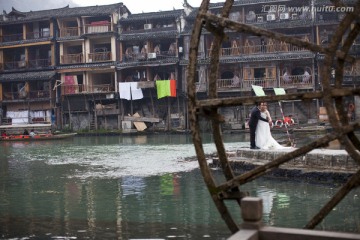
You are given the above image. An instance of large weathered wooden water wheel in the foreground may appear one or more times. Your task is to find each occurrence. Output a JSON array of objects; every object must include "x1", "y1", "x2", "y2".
[{"x1": 187, "y1": 0, "x2": 360, "y2": 233}]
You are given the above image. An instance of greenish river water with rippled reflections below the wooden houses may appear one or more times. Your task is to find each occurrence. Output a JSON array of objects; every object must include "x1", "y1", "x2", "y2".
[{"x1": 0, "y1": 135, "x2": 360, "y2": 239}]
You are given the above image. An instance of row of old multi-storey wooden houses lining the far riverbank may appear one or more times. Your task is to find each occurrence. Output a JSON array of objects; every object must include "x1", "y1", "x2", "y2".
[{"x1": 0, "y1": 0, "x2": 360, "y2": 131}]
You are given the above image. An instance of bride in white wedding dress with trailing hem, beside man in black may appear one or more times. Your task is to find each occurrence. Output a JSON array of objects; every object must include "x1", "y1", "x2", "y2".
[{"x1": 255, "y1": 111, "x2": 288, "y2": 149}]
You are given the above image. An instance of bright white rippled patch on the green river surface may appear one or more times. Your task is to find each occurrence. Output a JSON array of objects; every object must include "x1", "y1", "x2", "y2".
[{"x1": 19, "y1": 143, "x2": 248, "y2": 179}]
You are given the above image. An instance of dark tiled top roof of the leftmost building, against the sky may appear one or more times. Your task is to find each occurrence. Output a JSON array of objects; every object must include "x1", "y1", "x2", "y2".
[{"x1": 0, "y1": 3, "x2": 123, "y2": 25}]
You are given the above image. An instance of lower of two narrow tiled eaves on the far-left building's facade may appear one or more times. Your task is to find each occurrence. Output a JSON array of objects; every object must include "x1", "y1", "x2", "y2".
[{"x1": 0, "y1": 71, "x2": 56, "y2": 82}]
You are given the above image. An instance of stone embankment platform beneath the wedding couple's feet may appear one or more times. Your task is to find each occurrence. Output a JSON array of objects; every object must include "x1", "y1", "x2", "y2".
[{"x1": 211, "y1": 148, "x2": 360, "y2": 182}]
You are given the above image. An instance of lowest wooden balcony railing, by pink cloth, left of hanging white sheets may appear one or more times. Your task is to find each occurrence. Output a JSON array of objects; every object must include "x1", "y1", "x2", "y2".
[{"x1": 61, "y1": 84, "x2": 115, "y2": 95}]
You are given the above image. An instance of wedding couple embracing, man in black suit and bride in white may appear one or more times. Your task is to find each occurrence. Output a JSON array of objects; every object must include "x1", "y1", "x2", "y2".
[{"x1": 249, "y1": 102, "x2": 286, "y2": 149}]
